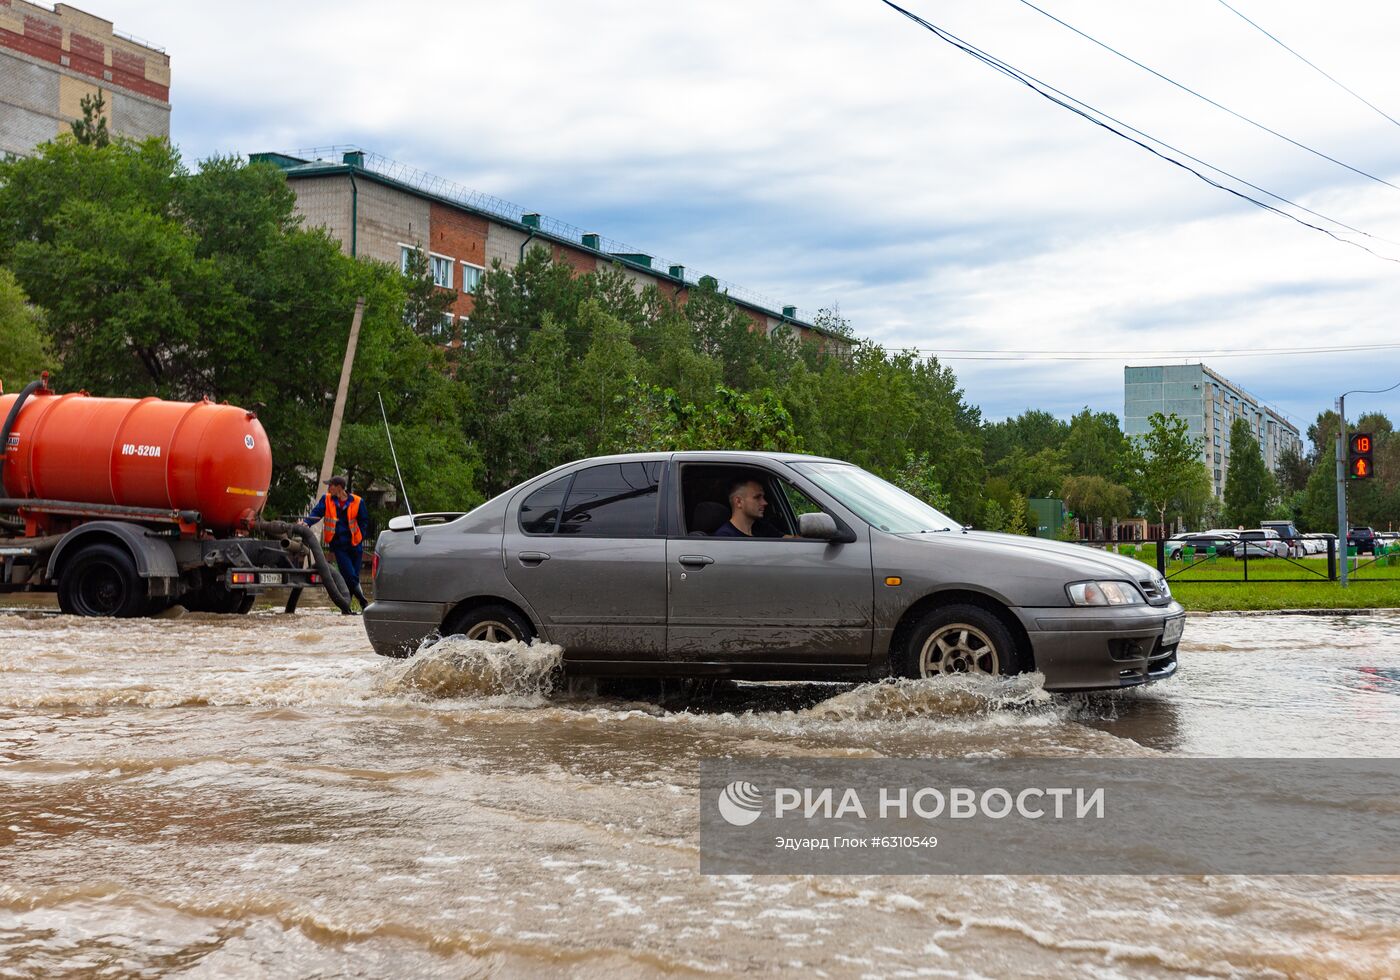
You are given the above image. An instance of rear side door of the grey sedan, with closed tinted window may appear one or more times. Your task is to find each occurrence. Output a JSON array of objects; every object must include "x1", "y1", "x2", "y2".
[{"x1": 503, "y1": 461, "x2": 666, "y2": 661}]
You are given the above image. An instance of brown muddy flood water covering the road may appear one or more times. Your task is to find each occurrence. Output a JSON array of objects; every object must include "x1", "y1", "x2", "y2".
[{"x1": 0, "y1": 610, "x2": 1400, "y2": 979}]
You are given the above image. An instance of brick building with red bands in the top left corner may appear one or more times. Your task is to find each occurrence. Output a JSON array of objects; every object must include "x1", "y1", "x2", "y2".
[{"x1": 0, "y1": 0, "x2": 171, "y2": 157}]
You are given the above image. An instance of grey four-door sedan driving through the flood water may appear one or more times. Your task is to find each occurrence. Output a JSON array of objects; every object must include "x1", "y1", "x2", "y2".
[{"x1": 364, "y1": 452, "x2": 1184, "y2": 690}]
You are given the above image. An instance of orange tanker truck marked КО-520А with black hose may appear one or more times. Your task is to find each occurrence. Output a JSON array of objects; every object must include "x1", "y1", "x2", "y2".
[{"x1": 0, "y1": 375, "x2": 350, "y2": 616}]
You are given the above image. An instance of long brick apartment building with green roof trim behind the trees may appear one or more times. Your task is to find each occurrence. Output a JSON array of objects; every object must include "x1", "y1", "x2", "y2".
[{"x1": 252, "y1": 150, "x2": 850, "y2": 347}]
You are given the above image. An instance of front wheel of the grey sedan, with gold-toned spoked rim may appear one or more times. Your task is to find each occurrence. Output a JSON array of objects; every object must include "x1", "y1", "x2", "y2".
[{"x1": 893, "y1": 603, "x2": 1026, "y2": 678}]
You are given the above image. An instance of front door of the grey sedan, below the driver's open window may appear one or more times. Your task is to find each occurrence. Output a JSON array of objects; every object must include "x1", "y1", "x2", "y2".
[{"x1": 666, "y1": 461, "x2": 874, "y2": 664}]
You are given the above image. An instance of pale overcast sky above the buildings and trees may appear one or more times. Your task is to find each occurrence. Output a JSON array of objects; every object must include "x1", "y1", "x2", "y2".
[{"x1": 93, "y1": 0, "x2": 1400, "y2": 430}]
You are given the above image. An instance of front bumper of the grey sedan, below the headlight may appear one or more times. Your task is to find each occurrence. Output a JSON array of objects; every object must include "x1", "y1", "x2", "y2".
[{"x1": 1016, "y1": 601, "x2": 1186, "y2": 690}]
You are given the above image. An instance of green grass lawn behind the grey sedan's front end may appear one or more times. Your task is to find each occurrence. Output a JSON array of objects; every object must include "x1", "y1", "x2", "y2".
[{"x1": 1086, "y1": 545, "x2": 1400, "y2": 612}]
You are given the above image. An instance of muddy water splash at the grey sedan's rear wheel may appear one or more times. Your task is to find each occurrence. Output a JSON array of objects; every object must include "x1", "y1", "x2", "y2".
[{"x1": 374, "y1": 636, "x2": 564, "y2": 704}]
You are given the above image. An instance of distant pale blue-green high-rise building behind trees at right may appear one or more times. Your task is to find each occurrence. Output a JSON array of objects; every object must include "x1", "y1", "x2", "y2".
[{"x1": 1123, "y1": 364, "x2": 1303, "y2": 497}]
